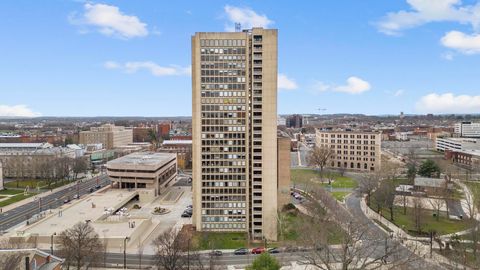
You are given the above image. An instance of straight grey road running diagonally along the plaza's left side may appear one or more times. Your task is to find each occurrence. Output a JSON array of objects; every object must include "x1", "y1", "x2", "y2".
[{"x1": 0, "y1": 175, "x2": 110, "y2": 232}]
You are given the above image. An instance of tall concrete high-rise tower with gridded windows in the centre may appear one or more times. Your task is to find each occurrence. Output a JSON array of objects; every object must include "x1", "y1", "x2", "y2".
[{"x1": 192, "y1": 28, "x2": 277, "y2": 240}]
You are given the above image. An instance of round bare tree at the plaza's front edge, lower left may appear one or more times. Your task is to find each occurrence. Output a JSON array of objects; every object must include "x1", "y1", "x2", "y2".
[{"x1": 58, "y1": 222, "x2": 103, "y2": 269}]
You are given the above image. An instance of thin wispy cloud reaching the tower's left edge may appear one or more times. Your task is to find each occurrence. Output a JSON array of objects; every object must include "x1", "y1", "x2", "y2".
[{"x1": 103, "y1": 61, "x2": 191, "y2": 77}]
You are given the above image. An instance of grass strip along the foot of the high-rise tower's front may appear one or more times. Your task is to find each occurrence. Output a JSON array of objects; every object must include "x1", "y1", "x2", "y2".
[{"x1": 192, "y1": 232, "x2": 248, "y2": 250}]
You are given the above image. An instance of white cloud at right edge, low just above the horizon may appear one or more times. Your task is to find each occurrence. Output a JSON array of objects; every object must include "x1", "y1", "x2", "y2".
[{"x1": 416, "y1": 93, "x2": 480, "y2": 113}]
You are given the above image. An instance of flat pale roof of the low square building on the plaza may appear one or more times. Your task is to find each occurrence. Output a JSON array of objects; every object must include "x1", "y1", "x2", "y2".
[{"x1": 107, "y1": 152, "x2": 177, "y2": 167}]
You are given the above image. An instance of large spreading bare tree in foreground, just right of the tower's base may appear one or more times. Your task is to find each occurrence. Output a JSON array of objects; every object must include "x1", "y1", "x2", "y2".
[{"x1": 298, "y1": 194, "x2": 418, "y2": 270}]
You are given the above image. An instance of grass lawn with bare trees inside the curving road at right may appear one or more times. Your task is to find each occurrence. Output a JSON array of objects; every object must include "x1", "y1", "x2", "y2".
[{"x1": 372, "y1": 204, "x2": 470, "y2": 235}]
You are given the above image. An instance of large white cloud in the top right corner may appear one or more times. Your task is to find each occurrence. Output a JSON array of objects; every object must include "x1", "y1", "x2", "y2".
[{"x1": 376, "y1": 0, "x2": 480, "y2": 35}]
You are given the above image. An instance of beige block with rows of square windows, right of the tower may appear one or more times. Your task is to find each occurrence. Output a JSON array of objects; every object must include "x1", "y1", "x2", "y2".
[{"x1": 316, "y1": 129, "x2": 382, "y2": 171}]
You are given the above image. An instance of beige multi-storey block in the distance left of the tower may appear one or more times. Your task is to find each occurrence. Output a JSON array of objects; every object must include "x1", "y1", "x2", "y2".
[{"x1": 80, "y1": 124, "x2": 133, "y2": 149}]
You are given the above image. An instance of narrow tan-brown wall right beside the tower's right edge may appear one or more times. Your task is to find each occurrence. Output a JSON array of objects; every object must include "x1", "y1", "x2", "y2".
[{"x1": 277, "y1": 137, "x2": 291, "y2": 210}]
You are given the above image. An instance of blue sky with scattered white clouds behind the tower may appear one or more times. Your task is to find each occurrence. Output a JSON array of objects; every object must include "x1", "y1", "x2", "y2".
[{"x1": 0, "y1": 0, "x2": 480, "y2": 116}]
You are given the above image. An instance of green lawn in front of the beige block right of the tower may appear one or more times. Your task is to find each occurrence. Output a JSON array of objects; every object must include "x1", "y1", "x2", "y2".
[{"x1": 290, "y1": 169, "x2": 357, "y2": 188}]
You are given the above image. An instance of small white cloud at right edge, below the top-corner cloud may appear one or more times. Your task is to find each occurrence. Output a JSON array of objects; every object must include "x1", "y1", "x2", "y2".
[{"x1": 441, "y1": 31, "x2": 480, "y2": 54}]
